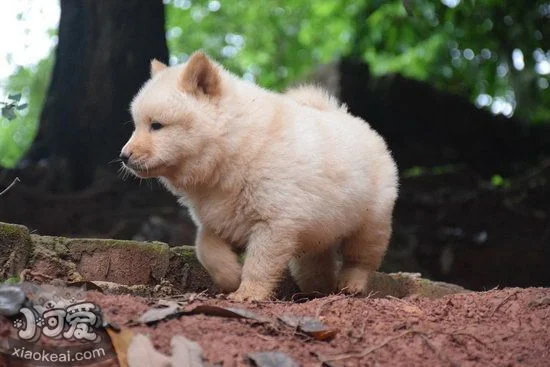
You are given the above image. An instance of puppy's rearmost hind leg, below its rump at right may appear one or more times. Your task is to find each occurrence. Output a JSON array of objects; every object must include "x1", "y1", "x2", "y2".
[{"x1": 338, "y1": 210, "x2": 392, "y2": 294}]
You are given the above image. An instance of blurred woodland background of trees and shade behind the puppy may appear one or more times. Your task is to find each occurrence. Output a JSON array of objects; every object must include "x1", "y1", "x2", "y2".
[{"x1": 0, "y1": 0, "x2": 550, "y2": 290}]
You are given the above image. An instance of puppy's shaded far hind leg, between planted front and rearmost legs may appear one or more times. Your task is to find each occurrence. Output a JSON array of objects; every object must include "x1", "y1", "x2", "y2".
[{"x1": 289, "y1": 247, "x2": 336, "y2": 294}]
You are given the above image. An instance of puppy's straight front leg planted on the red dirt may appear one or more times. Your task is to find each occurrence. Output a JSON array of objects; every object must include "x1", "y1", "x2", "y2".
[{"x1": 229, "y1": 223, "x2": 296, "y2": 301}]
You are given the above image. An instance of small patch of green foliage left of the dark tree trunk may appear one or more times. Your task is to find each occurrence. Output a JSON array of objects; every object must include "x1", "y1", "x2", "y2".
[{"x1": 0, "y1": 56, "x2": 53, "y2": 168}]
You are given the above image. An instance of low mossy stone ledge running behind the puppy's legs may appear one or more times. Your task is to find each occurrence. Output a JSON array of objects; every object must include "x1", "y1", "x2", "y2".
[{"x1": 0, "y1": 222, "x2": 468, "y2": 298}]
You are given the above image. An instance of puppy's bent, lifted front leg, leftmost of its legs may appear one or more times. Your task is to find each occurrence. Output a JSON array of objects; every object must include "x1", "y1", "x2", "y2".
[{"x1": 195, "y1": 228, "x2": 242, "y2": 292}]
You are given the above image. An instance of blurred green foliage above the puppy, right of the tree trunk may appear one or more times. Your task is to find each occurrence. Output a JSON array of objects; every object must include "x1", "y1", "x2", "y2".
[{"x1": 165, "y1": 0, "x2": 550, "y2": 122}]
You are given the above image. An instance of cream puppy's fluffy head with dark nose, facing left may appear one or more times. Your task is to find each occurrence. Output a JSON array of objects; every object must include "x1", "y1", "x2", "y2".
[{"x1": 120, "y1": 51, "x2": 222, "y2": 178}]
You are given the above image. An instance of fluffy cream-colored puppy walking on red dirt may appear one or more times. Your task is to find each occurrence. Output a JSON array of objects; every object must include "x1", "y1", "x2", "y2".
[{"x1": 121, "y1": 51, "x2": 398, "y2": 300}]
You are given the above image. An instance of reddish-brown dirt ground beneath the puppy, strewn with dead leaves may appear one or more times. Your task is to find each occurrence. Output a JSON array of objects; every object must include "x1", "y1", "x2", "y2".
[{"x1": 3, "y1": 288, "x2": 550, "y2": 366}]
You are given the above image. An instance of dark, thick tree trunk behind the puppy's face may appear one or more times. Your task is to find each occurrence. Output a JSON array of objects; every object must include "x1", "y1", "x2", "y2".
[{"x1": 35, "y1": 0, "x2": 168, "y2": 190}]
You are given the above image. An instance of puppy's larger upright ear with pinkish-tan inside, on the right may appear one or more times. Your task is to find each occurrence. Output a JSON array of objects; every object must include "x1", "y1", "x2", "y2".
[{"x1": 178, "y1": 51, "x2": 221, "y2": 97}]
